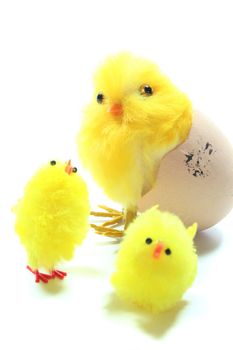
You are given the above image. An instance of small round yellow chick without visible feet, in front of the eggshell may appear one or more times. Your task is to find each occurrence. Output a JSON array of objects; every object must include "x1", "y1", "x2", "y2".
[{"x1": 112, "y1": 207, "x2": 197, "y2": 313}]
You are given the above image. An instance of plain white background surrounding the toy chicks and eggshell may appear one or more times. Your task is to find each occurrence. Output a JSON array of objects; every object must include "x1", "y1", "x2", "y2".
[{"x1": 0, "y1": 0, "x2": 233, "y2": 350}]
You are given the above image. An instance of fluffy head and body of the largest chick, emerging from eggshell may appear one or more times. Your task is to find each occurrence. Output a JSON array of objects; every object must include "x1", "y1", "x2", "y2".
[{"x1": 78, "y1": 53, "x2": 192, "y2": 234}]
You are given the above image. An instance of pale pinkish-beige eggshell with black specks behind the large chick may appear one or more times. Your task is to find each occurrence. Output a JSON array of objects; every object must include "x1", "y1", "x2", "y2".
[{"x1": 138, "y1": 111, "x2": 233, "y2": 230}]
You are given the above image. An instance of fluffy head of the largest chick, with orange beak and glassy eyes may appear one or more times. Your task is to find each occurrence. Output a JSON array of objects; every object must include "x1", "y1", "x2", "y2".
[{"x1": 86, "y1": 53, "x2": 191, "y2": 142}]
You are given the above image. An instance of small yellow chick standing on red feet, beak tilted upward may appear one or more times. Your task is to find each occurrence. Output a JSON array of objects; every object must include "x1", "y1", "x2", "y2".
[{"x1": 15, "y1": 160, "x2": 90, "y2": 283}]
